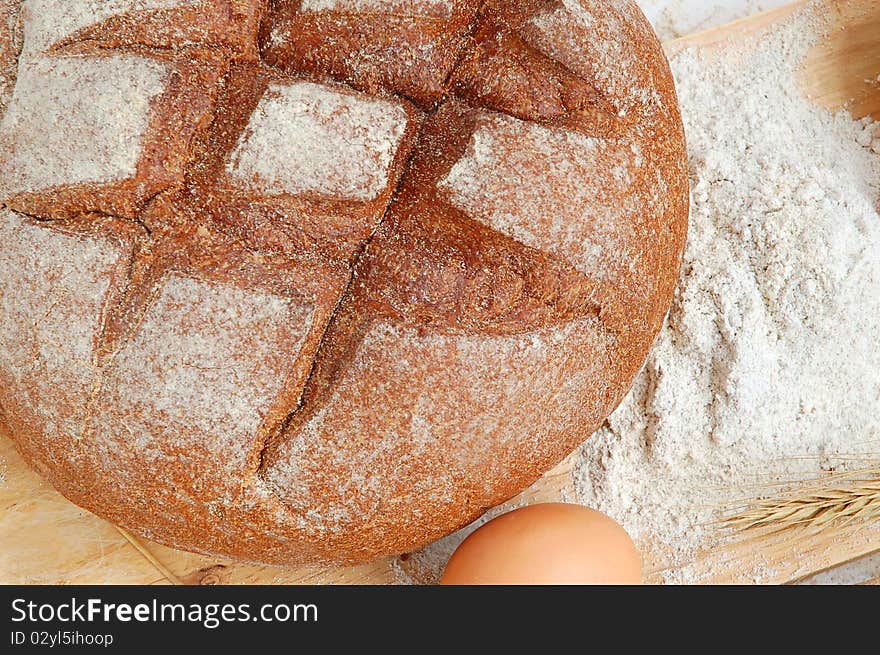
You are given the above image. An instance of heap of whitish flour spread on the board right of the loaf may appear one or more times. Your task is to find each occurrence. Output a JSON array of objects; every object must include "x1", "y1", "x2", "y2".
[{"x1": 577, "y1": 6, "x2": 880, "y2": 580}]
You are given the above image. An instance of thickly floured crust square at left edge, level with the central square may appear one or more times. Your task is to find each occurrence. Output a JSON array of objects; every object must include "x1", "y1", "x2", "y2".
[{"x1": 0, "y1": 56, "x2": 168, "y2": 196}]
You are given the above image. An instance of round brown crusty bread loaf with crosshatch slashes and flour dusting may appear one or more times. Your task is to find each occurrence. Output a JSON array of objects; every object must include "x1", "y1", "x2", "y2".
[{"x1": 0, "y1": 0, "x2": 688, "y2": 564}]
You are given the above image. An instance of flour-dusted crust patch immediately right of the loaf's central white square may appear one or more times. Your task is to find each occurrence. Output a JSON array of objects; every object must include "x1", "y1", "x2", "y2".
[{"x1": 439, "y1": 114, "x2": 644, "y2": 278}]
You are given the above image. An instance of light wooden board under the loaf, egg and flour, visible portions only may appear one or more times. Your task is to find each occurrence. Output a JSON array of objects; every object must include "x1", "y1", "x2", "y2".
[{"x1": 0, "y1": 0, "x2": 880, "y2": 584}]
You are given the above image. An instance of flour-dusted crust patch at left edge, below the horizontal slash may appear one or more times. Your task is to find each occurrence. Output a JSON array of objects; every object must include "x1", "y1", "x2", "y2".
[{"x1": 0, "y1": 210, "x2": 126, "y2": 448}]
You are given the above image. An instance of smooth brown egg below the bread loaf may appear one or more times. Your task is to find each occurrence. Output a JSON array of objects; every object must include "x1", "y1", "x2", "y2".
[{"x1": 440, "y1": 503, "x2": 642, "y2": 585}]
